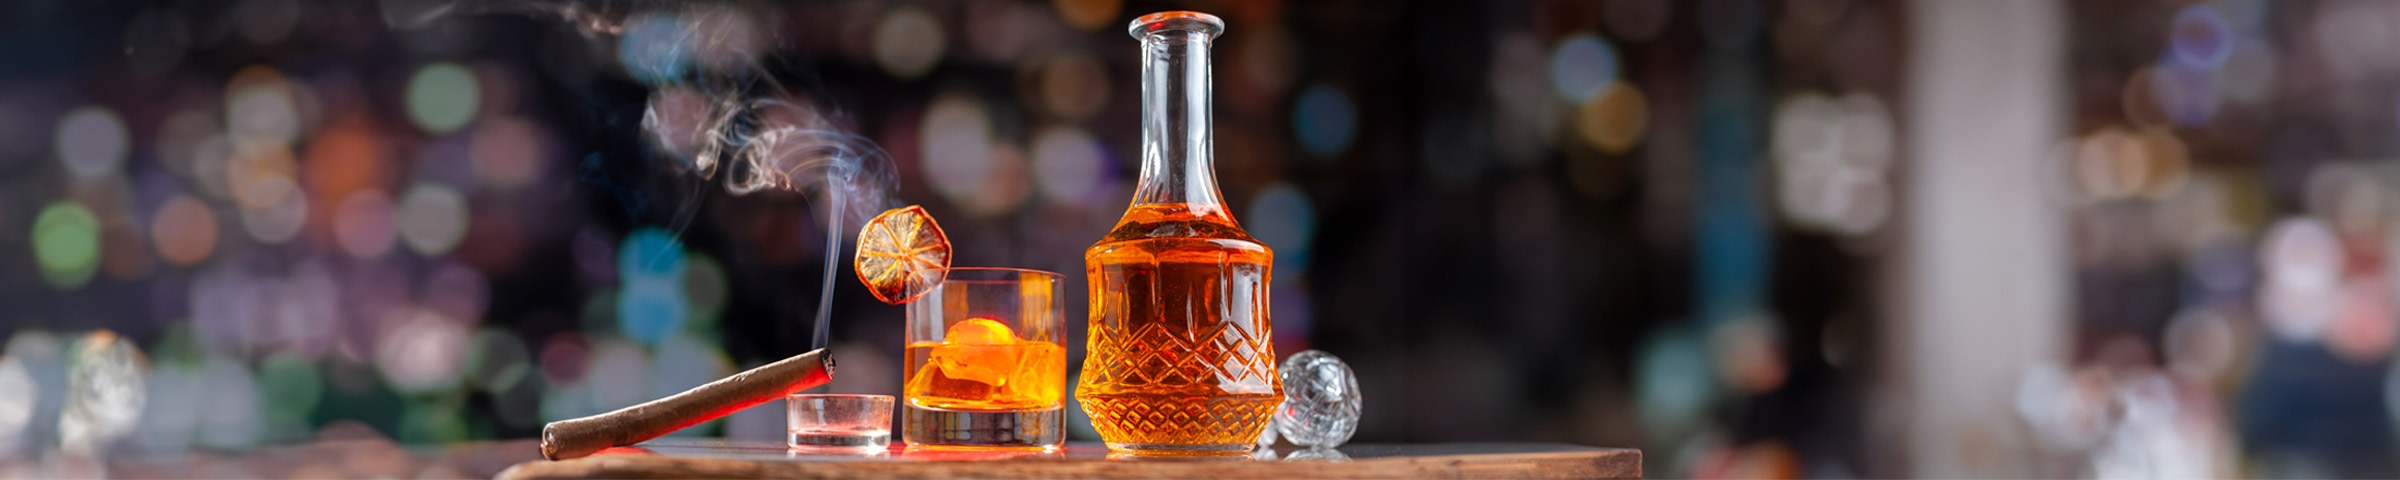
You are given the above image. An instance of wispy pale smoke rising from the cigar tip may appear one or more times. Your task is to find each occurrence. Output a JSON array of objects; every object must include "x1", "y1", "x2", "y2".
[{"x1": 382, "y1": 0, "x2": 900, "y2": 348}]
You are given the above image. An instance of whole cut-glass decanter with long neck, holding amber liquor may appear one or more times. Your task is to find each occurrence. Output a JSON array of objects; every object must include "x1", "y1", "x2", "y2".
[{"x1": 1075, "y1": 12, "x2": 1284, "y2": 456}]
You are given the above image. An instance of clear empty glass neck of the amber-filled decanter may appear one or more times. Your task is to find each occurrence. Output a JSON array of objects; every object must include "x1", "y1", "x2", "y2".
[{"x1": 1128, "y1": 12, "x2": 1224, "y2": 211}]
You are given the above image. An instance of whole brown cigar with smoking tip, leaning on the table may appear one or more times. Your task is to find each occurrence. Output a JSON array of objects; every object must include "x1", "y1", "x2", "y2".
[{"x1": 542, "y1": 348, "x2": 833, "y2": 461}]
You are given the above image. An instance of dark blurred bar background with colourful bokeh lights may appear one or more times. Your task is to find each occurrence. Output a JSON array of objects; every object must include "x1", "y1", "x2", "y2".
[{"x1": 0, "y1": 0, "x2": 2400, "y2": 478}]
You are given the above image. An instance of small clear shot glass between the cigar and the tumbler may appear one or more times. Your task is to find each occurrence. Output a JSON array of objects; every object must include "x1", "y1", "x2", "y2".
[{"x1": 785, "y1": 394, "x2": 893, "y2": 451}]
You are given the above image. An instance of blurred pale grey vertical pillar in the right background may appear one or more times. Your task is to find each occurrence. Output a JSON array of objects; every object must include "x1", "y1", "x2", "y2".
[{"x1": 1879, "y1": 0, "x2": 2069, "y2": 478}]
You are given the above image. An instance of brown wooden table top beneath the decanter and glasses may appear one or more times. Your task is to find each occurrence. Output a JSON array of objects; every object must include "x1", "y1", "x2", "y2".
[{"x1": 499, "y1": 439, "x2": 1642, "y2": 480}]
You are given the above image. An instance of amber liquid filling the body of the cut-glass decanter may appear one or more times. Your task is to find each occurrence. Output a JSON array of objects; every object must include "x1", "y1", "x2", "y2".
[{"x1": 1075, "y1": 204, "x2": 1284, "y2": 454}]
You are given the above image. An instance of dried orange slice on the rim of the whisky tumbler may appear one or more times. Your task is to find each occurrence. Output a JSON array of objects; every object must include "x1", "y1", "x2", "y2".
[{"x1": 857, "y1": 204, "x2": 950, "y2": 305}]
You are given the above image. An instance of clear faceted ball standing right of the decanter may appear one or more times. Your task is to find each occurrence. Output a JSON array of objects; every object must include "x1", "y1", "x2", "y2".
[{"x1": 1272, "y1": 350, "x2": 1361, "y2": 449}]
